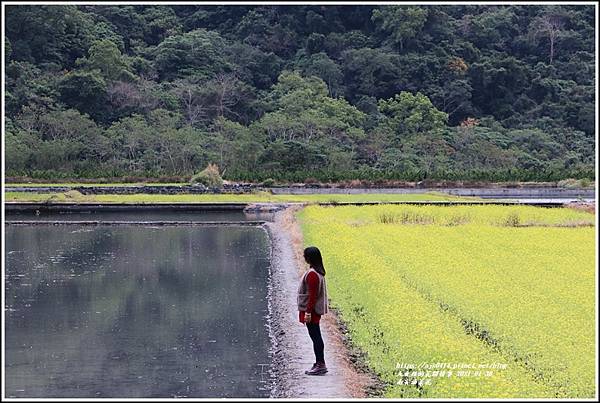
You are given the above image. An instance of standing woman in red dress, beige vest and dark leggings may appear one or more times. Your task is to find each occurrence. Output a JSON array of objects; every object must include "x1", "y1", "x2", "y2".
[{"x1": 298, "y1": 246, "x2": 328, "y2": 375}]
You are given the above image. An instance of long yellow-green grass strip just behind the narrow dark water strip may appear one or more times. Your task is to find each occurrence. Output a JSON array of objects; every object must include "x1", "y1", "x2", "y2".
[{"x1": 5, "y1": 190, "x2": 479, "y2": 203}]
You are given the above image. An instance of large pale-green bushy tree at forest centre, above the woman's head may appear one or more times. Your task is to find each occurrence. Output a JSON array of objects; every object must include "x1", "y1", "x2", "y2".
[{"x1": 250, "y1": 71, "x2": 365, "y2": 171}]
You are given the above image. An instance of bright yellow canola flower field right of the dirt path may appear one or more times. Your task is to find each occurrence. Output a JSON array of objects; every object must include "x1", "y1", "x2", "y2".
[{"x1": 298, "y1": 205, "x2": 596, "y2": 398}]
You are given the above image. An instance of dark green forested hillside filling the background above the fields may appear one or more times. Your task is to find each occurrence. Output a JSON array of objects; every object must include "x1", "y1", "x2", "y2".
[{"x1": 4, "y1": 5, "x2": 595, "y2": 180}]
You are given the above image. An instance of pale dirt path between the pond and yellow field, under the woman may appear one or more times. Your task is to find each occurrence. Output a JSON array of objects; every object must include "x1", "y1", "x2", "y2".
[{"x1": 266, "y1": 206, "x2": 376, "y2": 398}]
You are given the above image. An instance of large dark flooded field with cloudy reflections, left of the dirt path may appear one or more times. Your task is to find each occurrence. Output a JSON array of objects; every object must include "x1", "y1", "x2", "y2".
[{"x1": 5, "y1": 225, "x2": 269, "y2": 397}]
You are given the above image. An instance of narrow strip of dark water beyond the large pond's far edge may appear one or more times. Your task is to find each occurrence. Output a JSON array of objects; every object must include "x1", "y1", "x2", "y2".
[{"x1": 5, "y1": 209, "x2": 273, "y2": 222}]
